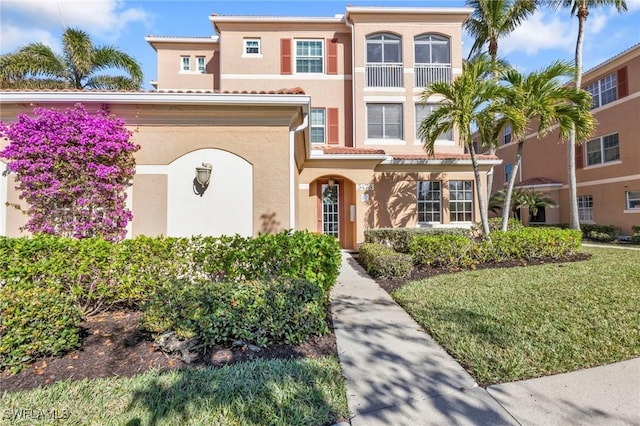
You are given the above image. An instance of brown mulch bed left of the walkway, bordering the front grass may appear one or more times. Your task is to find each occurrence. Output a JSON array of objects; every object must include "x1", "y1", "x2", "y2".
[{"x1": 0, "y1": 311, "x2": 338, "y2": 391}]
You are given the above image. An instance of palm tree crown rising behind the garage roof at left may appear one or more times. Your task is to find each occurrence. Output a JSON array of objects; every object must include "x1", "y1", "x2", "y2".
[{"x1": 0, "y1": 28, "x2": 142, "y2": 90}]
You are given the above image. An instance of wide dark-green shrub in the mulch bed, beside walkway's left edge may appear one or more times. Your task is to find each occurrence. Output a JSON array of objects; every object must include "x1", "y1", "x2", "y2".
[{"x1": 142, "y1": 278, "x2": 328, "y2": 346}]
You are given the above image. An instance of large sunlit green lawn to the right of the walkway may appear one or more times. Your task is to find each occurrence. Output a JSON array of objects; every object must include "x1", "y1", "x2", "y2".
[{"x1": 393, "y1": 247, "x2": 640, "y2": 386}]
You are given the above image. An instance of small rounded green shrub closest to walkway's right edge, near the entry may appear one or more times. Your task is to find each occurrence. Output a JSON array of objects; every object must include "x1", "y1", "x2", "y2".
[{"x1": 358, "y1": 243, "x2": 413, "y2": 278}]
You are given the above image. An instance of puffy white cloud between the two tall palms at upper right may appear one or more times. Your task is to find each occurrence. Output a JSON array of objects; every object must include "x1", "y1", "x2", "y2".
[{"x1": 499, "y1": 11, "x2": 580, "y2": 56}]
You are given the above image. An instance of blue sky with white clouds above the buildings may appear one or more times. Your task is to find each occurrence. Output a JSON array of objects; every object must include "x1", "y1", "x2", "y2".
[{"x1": 0, "y1": 0, "x2": 640, "y2": 89}]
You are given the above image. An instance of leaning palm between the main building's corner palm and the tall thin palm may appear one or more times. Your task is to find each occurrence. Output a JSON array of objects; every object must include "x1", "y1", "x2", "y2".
[{"x1": 497, "y1": 61, "x2": 594, "y2": 231}]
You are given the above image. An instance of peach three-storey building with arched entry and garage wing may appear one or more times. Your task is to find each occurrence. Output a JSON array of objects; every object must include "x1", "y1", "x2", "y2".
[{"x1": 0, "y1": 6, "x2": 500, "y2": 249}]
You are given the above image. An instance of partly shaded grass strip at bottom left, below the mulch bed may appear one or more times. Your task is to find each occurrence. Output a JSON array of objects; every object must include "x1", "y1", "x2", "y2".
[{"x1": 0, "y1": 357, "x2": 349, "y2": 426}]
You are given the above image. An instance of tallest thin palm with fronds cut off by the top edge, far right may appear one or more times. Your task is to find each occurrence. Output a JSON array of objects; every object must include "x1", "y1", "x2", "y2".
[{"x1": 551, "y1": 0, "x2": 627, "y2": 230}]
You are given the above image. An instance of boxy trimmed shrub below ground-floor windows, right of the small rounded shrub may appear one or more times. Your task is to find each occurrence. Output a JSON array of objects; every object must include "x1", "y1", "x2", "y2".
[{"x1": 410, "y1": 234, "x2": 478, "y2": 268}]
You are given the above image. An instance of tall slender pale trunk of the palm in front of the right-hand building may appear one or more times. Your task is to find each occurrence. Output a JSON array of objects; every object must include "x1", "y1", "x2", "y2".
[{"x1": 567, "y1": 1, "x2": 589, "y2": 230}]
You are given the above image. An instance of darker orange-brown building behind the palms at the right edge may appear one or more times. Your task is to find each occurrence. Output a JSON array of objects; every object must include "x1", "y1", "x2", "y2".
[{"x1": 493, "y1": 44, "x2": 640, "y2": 235}]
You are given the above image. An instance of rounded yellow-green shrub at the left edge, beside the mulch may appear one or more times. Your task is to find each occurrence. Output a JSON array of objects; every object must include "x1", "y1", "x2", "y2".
[{"x1": 0, "y1": 280, "x2": 82, "y2": 372}]
